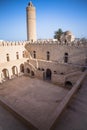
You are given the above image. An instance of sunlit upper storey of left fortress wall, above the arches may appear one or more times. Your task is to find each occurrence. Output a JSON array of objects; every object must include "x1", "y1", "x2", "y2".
[{"x1": 0, "y1": 41, "x2": 26, "y2": 63}]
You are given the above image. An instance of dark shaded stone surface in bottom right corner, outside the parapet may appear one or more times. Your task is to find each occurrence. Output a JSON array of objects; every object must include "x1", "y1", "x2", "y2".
[{"x1": 55, "y1": 76, "x2": 87, "y2": 130}]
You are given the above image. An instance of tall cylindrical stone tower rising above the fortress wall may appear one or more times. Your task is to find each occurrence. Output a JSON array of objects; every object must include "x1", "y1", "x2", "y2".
[{"x1": 26, "y1": 2, "x2": 36, "y2": 41}]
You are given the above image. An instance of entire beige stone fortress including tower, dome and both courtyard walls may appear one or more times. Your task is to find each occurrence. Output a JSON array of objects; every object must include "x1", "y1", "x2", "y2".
[{"x1": 0, "y1": 2, "x2": 87, "y2": 85}]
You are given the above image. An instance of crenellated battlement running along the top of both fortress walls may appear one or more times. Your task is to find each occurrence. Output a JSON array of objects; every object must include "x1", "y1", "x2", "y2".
[{"x1": 0, "y1": 39, "x2": 87, "y2": 47}]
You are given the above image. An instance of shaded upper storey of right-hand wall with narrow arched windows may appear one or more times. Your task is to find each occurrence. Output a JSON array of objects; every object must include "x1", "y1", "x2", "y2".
[{"x1": 25, "y1": 41, "x2": 87, "y2": 64}]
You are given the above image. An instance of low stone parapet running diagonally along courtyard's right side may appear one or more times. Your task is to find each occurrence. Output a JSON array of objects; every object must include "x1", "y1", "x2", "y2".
[{"x1": 46, "y1": 71, "x2": 87, "y2": 130}]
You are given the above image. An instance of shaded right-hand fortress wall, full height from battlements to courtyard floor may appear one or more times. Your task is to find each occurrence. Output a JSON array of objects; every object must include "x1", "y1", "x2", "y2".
[{"x1": 25, "y1": 40, "x2": 87, "y2": 85}]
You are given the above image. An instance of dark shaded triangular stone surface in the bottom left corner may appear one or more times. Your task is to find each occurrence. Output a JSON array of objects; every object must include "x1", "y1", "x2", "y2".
[{"x1": 0, "y1": 105, "x2": 30, "y2": 130}]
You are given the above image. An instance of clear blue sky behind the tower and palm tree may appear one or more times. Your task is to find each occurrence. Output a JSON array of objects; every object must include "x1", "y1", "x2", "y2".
[{"x1": 0, "y1": 0, "x2": 87, "y2": 41}]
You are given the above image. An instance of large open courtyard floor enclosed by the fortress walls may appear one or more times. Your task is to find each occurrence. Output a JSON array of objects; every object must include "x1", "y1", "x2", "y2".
[{"x1": 0, "y1": 76, "x2": 68, "y2": 130}]
